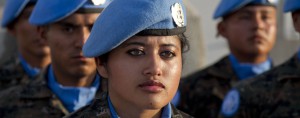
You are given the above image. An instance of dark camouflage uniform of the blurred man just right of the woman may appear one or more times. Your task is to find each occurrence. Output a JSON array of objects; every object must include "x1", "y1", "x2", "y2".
[{"x1": 178, "y1": 56, "x2": 239, "y2": 118}]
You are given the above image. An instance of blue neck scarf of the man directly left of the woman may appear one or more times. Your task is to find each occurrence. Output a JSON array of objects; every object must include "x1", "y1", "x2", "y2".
[{"x1": 48, "y1": 65, "x2": 100, "y2": 112}]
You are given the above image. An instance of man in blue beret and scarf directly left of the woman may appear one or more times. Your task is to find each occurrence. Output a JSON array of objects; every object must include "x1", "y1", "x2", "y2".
[{"x1": 0, "y1": 0, "x2": 109, "y2": 118}]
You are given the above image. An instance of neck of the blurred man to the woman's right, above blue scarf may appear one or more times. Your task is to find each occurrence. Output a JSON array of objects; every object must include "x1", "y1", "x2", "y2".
[{"x1": 233, "y1": 53, "x2": 268, "y2": 64}]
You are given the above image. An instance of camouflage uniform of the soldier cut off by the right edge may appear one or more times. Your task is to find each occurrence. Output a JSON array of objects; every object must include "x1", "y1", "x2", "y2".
[{"x1": 230, "y1": 56, "x2": 300, "y2": 118}]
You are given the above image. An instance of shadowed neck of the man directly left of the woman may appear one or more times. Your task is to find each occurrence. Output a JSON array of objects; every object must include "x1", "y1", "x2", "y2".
[{"x1": 52, "y1": 65, "x2": 96, "y2": 87}]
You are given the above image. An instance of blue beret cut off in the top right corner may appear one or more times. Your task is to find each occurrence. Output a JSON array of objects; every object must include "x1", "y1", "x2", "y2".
[{"x1": 283, "y1": 0, "x2": 300, "y2": 12}]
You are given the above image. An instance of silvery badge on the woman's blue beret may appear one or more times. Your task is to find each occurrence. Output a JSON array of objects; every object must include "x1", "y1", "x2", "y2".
[{"x1": 171, "y1": 3, "x2": 184, "y2": 27}]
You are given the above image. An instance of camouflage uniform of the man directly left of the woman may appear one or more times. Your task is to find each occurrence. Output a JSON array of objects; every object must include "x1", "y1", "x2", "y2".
[{"x1": 0, "y1": 68, "x2": 106, "y2": 118}]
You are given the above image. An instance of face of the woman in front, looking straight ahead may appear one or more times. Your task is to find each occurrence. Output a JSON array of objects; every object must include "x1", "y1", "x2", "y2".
[{"x1": 97, "y1": 36, "x2": 182, "y2": 110}]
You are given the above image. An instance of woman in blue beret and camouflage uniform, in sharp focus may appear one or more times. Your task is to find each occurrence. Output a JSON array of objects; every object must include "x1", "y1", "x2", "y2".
[{"x1": 67, "y1": 0, "x2": 190, "y2": 118}]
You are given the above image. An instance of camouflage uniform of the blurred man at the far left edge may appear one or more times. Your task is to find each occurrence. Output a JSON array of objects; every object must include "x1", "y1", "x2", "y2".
[{"x1": 0, "y1": 56, "x2": 34, "y2": 91}]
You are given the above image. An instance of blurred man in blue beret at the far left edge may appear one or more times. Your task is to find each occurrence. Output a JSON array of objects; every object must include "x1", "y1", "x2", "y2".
[{"x1": 0, "y1": 0, "x2": 51, "y2": 90}]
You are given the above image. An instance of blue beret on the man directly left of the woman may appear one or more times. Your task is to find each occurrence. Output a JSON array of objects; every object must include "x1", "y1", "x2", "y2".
[{"x1": 29, "y1": 0, "x2": 110, "y2": 25}]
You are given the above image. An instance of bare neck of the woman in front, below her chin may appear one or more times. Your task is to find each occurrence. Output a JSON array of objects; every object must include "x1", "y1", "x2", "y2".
[{"x1": 110, "y1": 94, "x2": 162, "y2": 118}]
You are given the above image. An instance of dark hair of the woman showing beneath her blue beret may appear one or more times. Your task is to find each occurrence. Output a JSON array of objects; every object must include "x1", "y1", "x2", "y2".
[{"x1": 96, "y1": 33, "x2": 190, "y2": 64}]
